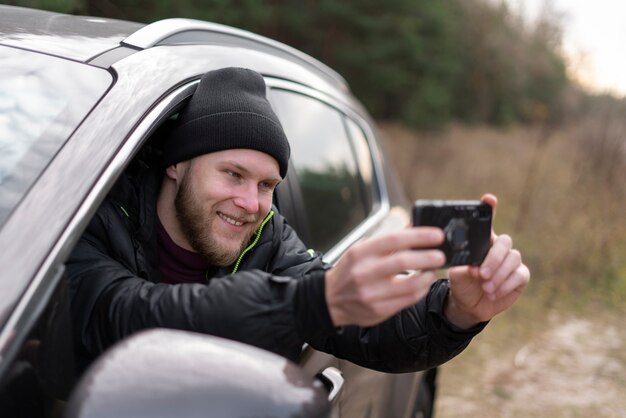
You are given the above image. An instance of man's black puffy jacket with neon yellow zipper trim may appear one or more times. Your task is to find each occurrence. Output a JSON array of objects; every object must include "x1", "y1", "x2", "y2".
[{"x1": 67, "y1": 160, "x2": 482, "y2": 372}]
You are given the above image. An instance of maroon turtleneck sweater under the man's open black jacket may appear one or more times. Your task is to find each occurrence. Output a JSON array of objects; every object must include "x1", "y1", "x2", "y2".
[{"x1": 157, "y1": 219, "x2": 211, "y2": 284}]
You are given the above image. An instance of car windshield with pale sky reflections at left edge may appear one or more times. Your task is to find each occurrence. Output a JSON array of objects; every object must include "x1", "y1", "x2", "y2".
[{"x1": 0, "y1": 47, "x2": 112, "y2": 225}]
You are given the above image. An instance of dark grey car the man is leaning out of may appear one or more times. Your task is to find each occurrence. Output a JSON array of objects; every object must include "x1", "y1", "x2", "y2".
[{"x1": 0, "y1": 6, "x2": 437, "y2": 418}]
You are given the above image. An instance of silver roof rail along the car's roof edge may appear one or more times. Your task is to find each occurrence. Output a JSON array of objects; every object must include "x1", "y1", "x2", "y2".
[{"x1": 122, "y1": 18, "x2": 348, "y2": 90}]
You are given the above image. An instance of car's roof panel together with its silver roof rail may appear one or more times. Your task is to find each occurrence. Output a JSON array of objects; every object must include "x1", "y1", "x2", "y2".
[{"x1": 0, "y1": 5, "x2": 349, "y2": 92}]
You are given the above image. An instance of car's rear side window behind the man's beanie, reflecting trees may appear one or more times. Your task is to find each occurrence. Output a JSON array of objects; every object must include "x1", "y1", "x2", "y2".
[{"x1": 271, "y1": 90, "x2": 373, "y2": 251}]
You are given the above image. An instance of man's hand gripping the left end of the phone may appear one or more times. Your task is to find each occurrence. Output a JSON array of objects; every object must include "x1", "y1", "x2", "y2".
[{"x1": 325, "y1": 227, "x2": 445, "y2": 327}]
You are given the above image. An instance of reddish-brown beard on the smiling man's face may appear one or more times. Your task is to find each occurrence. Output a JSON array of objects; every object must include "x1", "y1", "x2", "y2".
[{"x1": 174, "y1": 174, "x2": 260, "y2": 267}]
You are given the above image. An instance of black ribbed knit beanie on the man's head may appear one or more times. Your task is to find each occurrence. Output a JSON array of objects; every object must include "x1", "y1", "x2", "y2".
[{"x1": 161, "y1": 68, "x2": 290, "y2": 178}]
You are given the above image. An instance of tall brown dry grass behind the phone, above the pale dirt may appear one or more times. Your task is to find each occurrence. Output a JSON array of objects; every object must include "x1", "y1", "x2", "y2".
[{"x1": 381, "y1": 124, "x2": 626, "y2": 306}]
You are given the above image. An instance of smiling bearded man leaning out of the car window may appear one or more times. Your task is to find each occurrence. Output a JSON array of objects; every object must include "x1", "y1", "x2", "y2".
[{"x1": 68, "y1": 68, "x2": 529, "y2": 372}]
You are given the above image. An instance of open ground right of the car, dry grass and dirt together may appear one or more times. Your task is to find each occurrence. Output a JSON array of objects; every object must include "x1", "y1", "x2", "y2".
[{"x1": 381, "y1": 121, "x2": 626, "y2": 418}]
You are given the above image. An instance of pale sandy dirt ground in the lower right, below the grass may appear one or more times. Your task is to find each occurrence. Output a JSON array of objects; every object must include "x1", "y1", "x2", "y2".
[{"x1": 435, "y1": 306, "x2": 626, "y2": 418}]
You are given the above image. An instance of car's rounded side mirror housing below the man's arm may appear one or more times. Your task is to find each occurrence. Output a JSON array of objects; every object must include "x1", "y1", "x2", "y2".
[{"x1": 66, "y1": 329, "x2": 330, "y2": 418}]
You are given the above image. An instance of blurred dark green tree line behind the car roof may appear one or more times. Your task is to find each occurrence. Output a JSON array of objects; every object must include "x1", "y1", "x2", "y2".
[{"x1": 13, "y1": 0, "x2": 571, "y2": 128}]
